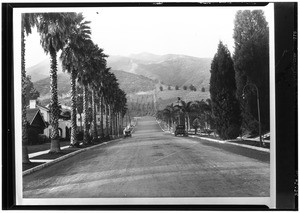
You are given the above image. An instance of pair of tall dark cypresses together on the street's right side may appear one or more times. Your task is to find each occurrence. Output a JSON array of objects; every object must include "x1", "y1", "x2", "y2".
[{"x1": 210, "y1": 10, "x2": 270, "y2": 139}]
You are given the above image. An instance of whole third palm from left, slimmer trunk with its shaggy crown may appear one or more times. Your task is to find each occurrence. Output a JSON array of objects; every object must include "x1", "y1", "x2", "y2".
[{"x1": 60, "y1": 13, "x2": 91, "y2": 147}]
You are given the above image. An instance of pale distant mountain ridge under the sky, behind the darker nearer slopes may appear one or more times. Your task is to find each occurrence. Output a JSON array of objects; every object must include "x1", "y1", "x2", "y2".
[{"x1": 107, "y1": 53, "x2": 212, "y2": 90}]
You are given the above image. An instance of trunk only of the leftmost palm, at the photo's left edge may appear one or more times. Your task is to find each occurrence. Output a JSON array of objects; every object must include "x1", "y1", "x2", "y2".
[{"x1": 21, "y1": 22, "x2": 30, "y2": 163}]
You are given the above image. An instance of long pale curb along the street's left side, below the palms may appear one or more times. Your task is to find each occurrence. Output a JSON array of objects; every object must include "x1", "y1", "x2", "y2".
[{"x1": 22, "y1": 138, "x2": 121, "y2": 176}]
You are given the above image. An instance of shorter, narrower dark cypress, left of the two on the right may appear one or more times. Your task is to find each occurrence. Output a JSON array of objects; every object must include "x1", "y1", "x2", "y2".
[{"x1": 210, "y1": 42, "x2": 241, "y2": 139}]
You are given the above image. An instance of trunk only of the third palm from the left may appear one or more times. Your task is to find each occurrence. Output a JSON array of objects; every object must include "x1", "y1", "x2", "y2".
[{"x1": 70, "y1": 70, "x2": 77, "y2": 146}]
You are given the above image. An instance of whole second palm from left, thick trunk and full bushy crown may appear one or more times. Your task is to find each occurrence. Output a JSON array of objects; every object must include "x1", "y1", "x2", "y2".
[{"x1": 37, "y1": 13, "x2": 77, "y2": 153}]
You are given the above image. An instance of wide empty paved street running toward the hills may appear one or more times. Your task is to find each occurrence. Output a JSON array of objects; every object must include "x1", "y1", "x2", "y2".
[{"x1": 23, "y1": 117, "x2": 270, "y2": 198}]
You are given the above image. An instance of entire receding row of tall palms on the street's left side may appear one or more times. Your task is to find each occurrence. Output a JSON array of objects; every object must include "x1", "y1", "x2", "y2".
[{"x1": 21, "y1": 13, "x2": 127, "y2": 163}]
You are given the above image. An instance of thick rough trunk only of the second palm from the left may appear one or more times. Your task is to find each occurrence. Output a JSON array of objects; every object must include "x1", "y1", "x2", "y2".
[{"x1": 49, "y1": 48, "x2": 61, "y2": 153}]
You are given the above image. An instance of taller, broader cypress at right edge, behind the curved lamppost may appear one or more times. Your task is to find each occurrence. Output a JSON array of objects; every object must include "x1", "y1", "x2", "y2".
[{"x1": 233, "y1": 10, "x2": 270, "y2": 134}]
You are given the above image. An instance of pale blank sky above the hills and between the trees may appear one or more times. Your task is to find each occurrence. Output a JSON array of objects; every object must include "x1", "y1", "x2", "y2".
[{"x1": 26, "y1": 7, "x2": 269, "y2": 67}]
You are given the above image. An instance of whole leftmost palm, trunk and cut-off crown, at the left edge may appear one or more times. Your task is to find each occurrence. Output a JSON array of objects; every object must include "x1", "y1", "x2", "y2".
[{"x1": 21, "y1": 13, "x2": 38, "y2": 163}]
